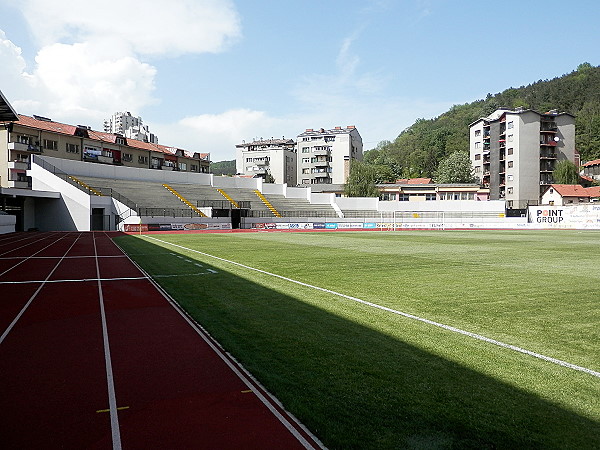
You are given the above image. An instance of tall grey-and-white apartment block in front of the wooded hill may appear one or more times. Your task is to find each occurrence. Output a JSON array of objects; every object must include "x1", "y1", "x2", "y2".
[{"x1": 469, "y1": 109, "x2": 577, "y2": 209}]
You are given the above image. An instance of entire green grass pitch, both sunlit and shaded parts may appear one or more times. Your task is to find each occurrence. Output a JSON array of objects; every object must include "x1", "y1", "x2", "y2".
[{"x1": 117, "y1": 231, "x2": 600, "y2": 449}]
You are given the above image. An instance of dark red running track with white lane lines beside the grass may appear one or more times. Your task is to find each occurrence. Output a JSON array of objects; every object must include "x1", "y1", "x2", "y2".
[{"x1": 0, "y1": 232, "x2": 321, "y2": 449}]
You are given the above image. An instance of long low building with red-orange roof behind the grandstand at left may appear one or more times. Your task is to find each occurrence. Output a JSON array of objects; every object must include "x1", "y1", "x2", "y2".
[{"x1": 0, "y1": 114, "x2": 210, "y2": 189}]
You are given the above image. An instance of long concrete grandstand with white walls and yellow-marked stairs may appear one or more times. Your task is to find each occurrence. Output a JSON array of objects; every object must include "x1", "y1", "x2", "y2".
[{"x1": 10, "y1": 155, "x2": 527, "y2": 231}]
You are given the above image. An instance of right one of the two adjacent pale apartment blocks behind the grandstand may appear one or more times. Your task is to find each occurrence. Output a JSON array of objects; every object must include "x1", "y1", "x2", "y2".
[{"x1": 296, "y1": 125, "x2": 363, "y2": 186}]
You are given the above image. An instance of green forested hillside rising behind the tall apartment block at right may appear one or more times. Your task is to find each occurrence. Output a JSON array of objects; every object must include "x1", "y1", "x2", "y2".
[{"x1": 365, "y1": 63, "x2": 600, "y2": 179}]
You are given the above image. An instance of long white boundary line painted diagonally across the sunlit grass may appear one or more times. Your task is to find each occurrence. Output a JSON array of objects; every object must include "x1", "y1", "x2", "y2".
[{"x1": 145, "y1": 236, "x2": 600, "y2": 378}]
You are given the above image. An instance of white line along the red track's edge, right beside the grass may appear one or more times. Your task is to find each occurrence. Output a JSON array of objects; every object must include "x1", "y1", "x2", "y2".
[{"x1": 113, "y1": 237, "x2": 326, "y2": 449}]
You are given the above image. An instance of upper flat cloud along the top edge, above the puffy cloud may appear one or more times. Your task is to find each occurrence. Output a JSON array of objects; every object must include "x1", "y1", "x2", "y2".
[{"x1": 19, "y1": 0, "x2": 241, "y2": 56}]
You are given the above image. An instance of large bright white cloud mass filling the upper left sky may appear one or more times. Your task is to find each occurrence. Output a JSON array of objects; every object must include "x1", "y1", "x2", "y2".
[{"x1": 0, "y1": 0, "x2": 241, "y2": 125}]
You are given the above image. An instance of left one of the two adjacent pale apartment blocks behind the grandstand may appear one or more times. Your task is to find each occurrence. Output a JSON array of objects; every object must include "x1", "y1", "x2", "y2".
[{"x1": 235, "y1": 138, "x2": 297, "y2": 186}]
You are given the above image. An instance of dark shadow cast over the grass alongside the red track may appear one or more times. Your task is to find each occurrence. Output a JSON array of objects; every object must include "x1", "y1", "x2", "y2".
[{"x1": 118, "y1": 237, "x2": 600, "y2": 448}]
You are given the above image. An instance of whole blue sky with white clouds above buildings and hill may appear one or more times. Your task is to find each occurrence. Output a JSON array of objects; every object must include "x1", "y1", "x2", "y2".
[{"x1": 0, "y1": 0, "x2": 600, "y2": 161}]
